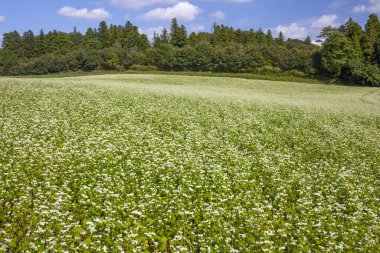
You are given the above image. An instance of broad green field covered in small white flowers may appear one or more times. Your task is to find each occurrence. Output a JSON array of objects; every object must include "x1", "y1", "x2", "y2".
[{"x1": 0, "y1": 75, "x2": 380, "y2": 252}]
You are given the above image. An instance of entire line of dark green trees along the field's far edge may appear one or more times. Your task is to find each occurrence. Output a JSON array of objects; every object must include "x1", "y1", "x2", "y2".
[{"x1": 0, "y1": 14, "x2": 380, "y2": 86}]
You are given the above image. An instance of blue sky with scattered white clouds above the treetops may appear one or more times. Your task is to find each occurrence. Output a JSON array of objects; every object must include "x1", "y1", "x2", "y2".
[{"x1": 0, "y1": 0, "x2": 380, "y2": 39}]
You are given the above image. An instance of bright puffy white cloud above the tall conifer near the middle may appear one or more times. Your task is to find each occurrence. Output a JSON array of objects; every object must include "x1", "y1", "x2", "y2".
[{"x1": 142, "y1": 2, "x2": 201, "y2": 21}]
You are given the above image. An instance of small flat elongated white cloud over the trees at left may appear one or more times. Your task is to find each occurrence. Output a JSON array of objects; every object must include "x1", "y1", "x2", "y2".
[{"x1": 58, "y1": 6, "x2": 111, "y2": 19}]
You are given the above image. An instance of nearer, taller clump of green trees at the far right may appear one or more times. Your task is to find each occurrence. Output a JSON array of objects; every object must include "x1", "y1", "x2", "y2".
[{"x1": 313, "y1": 14, "x2": 380, "y2": 86}]
